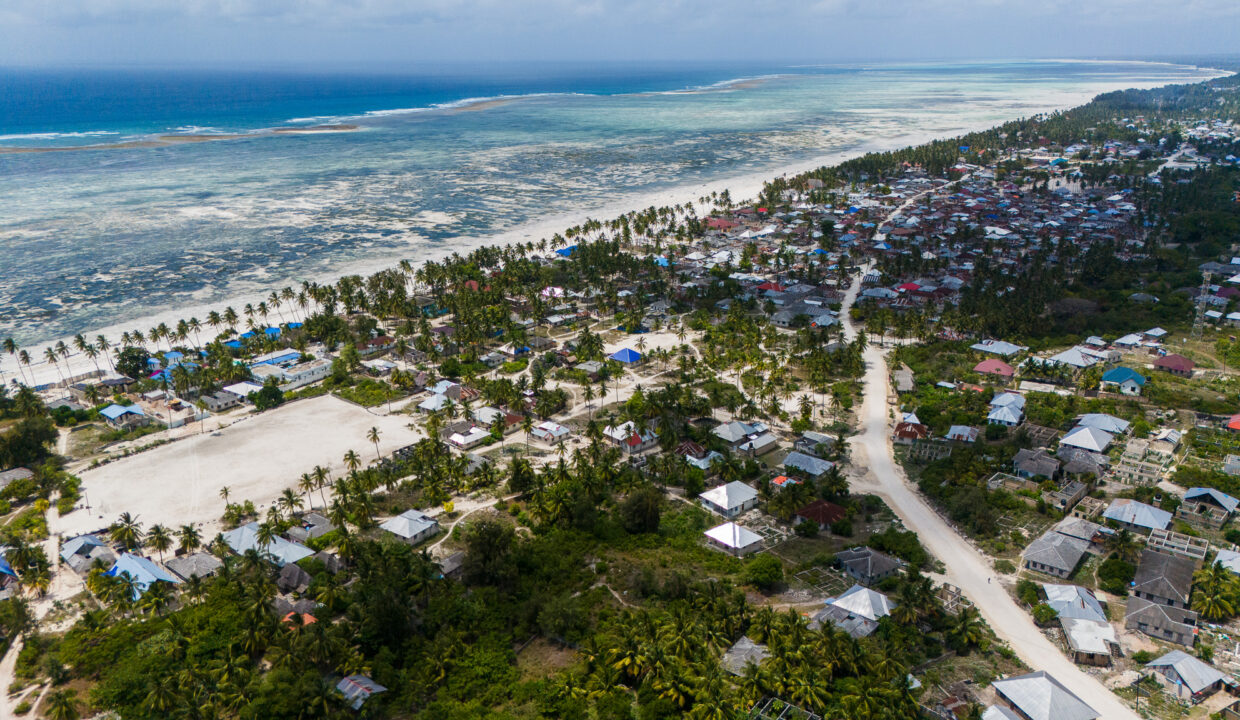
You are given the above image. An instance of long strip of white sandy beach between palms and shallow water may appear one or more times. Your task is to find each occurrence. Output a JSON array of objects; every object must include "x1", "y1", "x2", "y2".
[{"x1": 7, "y1": 71, "x2": 1230, "y2": 385}]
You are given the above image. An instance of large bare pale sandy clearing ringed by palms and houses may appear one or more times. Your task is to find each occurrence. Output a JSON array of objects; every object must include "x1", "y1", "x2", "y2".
[{"x1": 52, "y1": 395, "x2": 422, "y2": 537}]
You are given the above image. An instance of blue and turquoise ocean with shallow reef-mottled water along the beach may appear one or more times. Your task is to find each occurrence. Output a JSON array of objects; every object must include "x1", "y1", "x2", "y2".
[{"x1": 0, "y1": 61, "x2": 1219, "y2": 346}]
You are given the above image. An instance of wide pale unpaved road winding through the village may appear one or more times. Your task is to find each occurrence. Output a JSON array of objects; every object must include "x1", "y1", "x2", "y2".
[{"x1": 841, "y1": 270, "x2": 1138, "y2": 720}]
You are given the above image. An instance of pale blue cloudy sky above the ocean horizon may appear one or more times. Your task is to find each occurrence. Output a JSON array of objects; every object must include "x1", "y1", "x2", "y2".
[{"x1": 0, "y1": 0, "x2": 1240, "y2": 69}]
